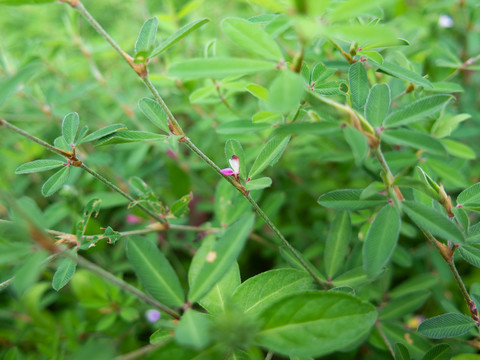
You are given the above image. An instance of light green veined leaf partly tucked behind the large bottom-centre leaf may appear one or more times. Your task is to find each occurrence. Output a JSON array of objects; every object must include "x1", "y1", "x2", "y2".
[{"x1": 233, "y1": 268, "x2": 313, "y2": 314}]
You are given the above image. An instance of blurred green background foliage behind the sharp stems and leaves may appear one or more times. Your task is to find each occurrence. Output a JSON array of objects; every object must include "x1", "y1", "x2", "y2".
[{"x1": 0, "y1": 0, "x2": 480, "y2": 359}]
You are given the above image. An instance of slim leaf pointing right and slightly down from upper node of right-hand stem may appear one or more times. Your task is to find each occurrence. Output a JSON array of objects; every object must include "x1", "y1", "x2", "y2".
[{"x1": 381, "y1": 129, "x2": 446, "y2": 156}]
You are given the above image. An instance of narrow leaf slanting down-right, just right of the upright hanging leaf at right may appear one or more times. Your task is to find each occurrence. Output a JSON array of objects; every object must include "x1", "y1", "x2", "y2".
[{"x1": 402, "y1": 201, "x2": 465, "y2": 244}]
